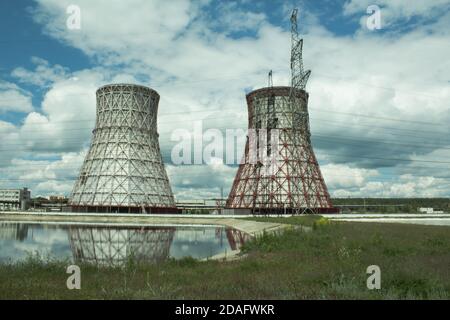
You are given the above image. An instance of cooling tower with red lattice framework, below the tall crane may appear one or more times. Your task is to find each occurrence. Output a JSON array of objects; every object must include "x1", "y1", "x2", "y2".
[{"x1": 226, "y1": 87, "x2": 336, "y2": 213}]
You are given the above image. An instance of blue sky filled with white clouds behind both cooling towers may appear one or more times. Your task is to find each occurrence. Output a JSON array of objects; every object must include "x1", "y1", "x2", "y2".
[{"x1": 0, "y1": 0, "x2": 450, "y2": 199}]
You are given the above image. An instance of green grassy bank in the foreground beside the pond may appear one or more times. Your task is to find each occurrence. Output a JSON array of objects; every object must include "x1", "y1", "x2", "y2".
[{"x1": 0, "y1": 216, "x2": 450, "y2": 299}]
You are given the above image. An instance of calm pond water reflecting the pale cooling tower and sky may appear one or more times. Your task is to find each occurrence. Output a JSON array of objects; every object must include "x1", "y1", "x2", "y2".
[{"x1": 0, "y1": 222, "x2": 248, "y2": 266}]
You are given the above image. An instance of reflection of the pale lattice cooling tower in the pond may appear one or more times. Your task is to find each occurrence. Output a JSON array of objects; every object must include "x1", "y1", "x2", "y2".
[{"x1": 69, "y1": 227, "x2": 175, "y2": 266}]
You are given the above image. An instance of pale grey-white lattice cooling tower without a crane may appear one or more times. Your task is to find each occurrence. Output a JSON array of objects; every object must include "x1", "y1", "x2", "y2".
[{"x1": 70, "y1": 84, "x2": 175, "y2": 213}]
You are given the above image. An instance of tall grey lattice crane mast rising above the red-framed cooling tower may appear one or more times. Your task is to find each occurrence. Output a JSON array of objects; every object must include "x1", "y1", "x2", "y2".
[{"x1": 291, "y1": 8, "x2": 311, "y2": 96}]
